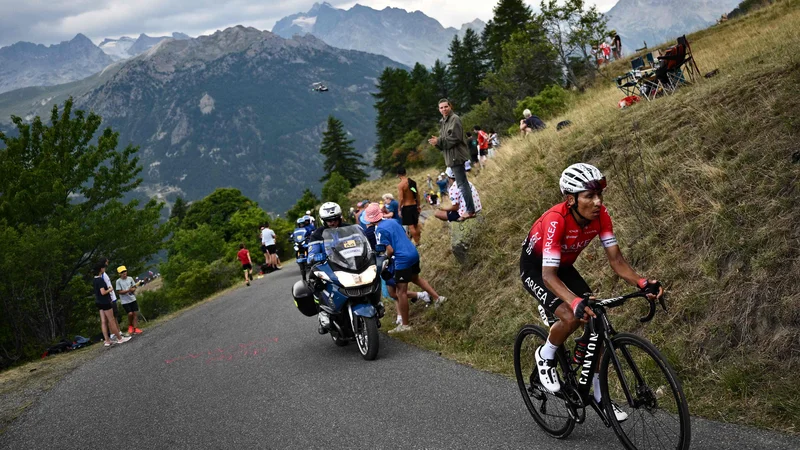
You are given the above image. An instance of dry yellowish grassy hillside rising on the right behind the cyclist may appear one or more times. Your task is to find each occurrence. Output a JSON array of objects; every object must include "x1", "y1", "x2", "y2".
[{"x1": 353, "y1": 0, "x2": 800, "y2": 432}]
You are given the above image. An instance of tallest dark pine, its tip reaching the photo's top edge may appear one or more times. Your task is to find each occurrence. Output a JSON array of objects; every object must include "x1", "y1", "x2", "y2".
[{"x1": 482, "y1": 0, "x2": 532, "y2": 72}]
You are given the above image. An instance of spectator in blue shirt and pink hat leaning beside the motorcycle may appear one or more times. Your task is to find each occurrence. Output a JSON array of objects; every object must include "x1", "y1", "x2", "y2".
[{"x1": 364, "y1": 203, "x2": 447, "y2": 333}]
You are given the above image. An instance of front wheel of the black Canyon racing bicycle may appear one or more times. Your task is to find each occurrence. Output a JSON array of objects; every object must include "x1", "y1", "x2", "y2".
[{"x1": 600, "y1": 333, "x2": 691, "y2": 450}]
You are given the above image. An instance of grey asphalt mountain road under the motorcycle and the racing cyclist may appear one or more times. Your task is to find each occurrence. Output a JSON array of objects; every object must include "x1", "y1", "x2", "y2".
[{"x1": 0, "y1": 263, "x2": 800, "y2": 450}]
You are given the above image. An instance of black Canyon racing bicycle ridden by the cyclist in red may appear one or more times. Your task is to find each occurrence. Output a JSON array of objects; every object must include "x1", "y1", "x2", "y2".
[{"x1": 514, "y1": 291, "x2": 691, "y2": 449}]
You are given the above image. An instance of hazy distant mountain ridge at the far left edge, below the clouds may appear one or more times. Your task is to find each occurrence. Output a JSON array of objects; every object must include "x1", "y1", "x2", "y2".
[{"x1": 0, "y1": 33, "x2": 113, "y2": 93}]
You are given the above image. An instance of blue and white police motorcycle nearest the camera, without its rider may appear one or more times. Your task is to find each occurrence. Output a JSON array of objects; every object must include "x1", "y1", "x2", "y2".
[{"x1": 292, "y1": 225, "x2": 384, "y2": 361}]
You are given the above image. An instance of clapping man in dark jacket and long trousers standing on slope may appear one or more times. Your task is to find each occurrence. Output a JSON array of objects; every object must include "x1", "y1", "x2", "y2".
[{"x1": 428, "y1": 98, "x2": 475, "y2": 220}]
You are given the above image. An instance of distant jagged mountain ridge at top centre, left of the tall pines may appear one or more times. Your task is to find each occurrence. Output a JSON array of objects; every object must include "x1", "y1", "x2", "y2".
[{"x1": 272, "y1": 2, "x2": 486, "y2": 67}]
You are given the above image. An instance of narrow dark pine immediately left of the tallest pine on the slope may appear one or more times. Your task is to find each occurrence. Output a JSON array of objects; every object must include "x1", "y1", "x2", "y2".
[{"x1": 450, "y1": 28, "x2": 486, "y2": 112}]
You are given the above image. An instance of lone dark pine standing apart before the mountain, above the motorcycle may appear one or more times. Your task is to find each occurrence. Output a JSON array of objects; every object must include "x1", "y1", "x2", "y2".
[{"x1": 319, "y1": 116, "x2": 367, "y2": 187}]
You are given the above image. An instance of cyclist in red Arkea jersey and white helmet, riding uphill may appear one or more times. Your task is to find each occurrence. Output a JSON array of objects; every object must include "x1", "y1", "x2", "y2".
[{"x1": 520, "y1": 163, "x2": 663, "y2": 420}]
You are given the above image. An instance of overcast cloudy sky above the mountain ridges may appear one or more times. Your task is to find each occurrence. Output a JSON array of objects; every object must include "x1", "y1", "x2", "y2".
[{"x1": 0, "y1": 0, "x2": 617, "y2": 47}]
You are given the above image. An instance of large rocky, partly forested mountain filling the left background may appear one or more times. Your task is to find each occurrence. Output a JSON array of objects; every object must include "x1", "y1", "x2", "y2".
[{"x1": 0, "y1": 26, "x2": 399, "y2": 213}]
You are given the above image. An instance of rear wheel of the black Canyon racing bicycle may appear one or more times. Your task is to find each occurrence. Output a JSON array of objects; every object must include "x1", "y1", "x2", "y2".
[{"x1": 514, "y1": 325, "x2": 575, "y2": 439}]
